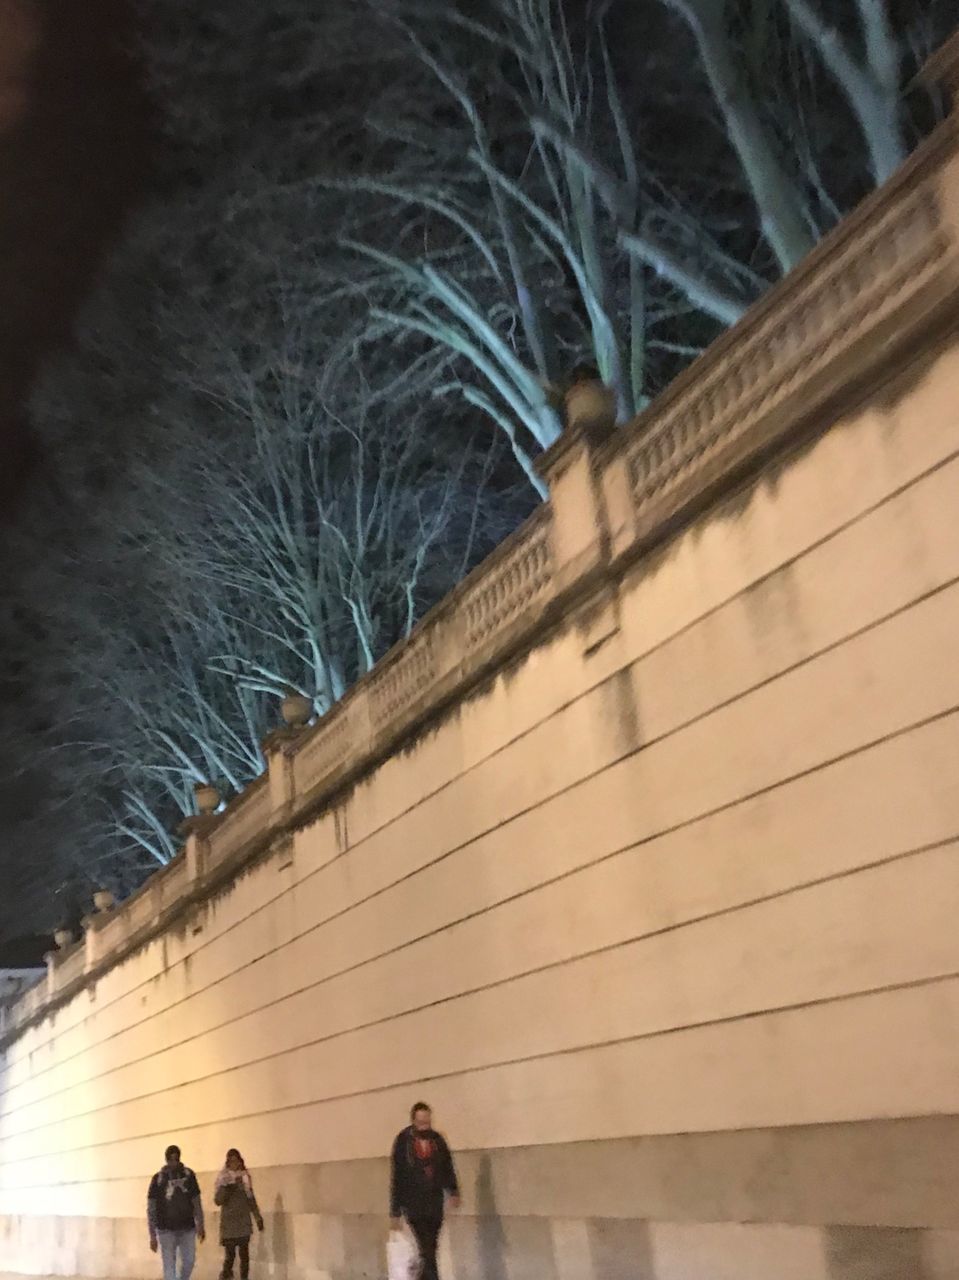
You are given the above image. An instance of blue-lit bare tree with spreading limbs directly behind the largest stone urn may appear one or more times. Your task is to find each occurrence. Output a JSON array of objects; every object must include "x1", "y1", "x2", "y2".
[{"x1": 314, "y1": 3, "x2": 649, "y2": 483}]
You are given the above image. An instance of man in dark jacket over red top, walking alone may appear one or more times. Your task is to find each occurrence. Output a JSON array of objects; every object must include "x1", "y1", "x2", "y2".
[{"x1": 389, "y1": 1102, "x2": 460, "y2": 1280}]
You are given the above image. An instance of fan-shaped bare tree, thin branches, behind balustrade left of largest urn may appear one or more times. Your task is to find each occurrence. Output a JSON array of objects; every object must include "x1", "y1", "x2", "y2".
[{"x1": 141, "y1": 309, "x2": 516, "y2": 712}]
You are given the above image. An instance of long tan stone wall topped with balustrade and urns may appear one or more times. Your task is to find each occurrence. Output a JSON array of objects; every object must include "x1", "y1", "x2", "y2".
[{"x1": 0, "y1": 30, "x2": 959, "y2": 1280}]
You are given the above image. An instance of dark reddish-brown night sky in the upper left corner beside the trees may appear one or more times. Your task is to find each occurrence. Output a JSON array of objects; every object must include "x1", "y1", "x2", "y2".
[{"x1": 0, "y1": 0, "x2": 149, "y2": 520}]
